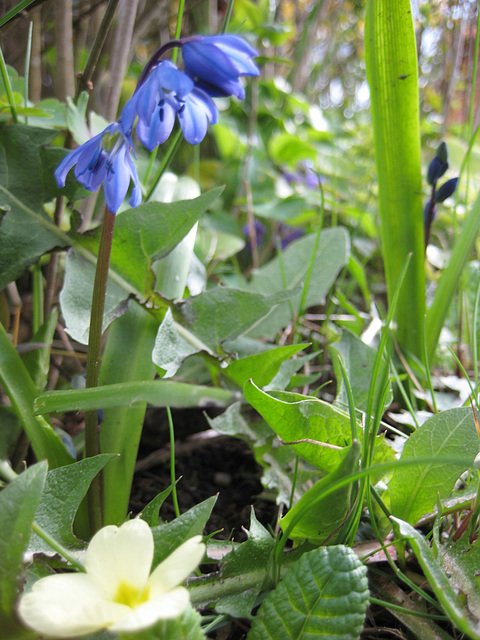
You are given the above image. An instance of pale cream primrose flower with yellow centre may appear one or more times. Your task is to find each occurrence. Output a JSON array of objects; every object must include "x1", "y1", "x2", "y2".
[{"x1": 18, "y1": 519, "x2": 205, "y2": 638}]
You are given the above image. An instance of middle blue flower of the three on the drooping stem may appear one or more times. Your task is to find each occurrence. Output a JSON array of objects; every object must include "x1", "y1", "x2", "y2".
[{"x1": 121, "y1": 60, "x2": 218, "y2": 151}]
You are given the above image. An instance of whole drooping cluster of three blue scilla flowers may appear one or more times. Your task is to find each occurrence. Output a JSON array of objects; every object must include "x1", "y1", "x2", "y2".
[{"x1": 55, "y1": 35, "x2": 259, "y2": 213}]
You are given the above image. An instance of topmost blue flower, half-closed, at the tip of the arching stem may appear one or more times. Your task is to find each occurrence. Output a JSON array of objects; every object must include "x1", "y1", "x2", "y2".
[{"x1": 180, "y1": 35, "x2": 260, "y2": 100}]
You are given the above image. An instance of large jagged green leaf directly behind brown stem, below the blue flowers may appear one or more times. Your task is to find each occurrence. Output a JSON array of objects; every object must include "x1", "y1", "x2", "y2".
[{"x1": 60, "y1": 188, "x2": 222, "y2": 344}]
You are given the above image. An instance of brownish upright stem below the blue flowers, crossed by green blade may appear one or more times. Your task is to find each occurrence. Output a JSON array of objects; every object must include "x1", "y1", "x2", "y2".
[{"x1": 85, "y1": 208, "x2": 115, "y2": 533}]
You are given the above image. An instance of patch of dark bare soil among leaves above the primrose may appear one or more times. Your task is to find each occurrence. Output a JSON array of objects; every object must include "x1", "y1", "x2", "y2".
[{"x1": 130, "y1": 409, "x2": 276, "y2": 542}]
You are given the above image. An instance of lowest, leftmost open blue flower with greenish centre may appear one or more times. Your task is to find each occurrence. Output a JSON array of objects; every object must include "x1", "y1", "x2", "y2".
[{"x1": 55, "y1": 122, "x2": 142, "y2": 213}]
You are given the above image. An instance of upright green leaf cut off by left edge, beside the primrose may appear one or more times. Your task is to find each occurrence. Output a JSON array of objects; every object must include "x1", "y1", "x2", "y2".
[{"x1": 0, "y1": 462, "x2": 47, "y2": 624}]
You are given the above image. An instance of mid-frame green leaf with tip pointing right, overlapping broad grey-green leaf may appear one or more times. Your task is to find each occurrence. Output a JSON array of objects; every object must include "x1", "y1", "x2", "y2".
[{"x1": 173, "y1": 287, "x2": 296, "y2": 351}]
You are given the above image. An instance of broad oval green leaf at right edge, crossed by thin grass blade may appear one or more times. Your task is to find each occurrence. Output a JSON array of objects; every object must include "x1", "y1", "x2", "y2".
[{"x1": 388, "y1": 408, "x2": 478, "y2": 524}]
